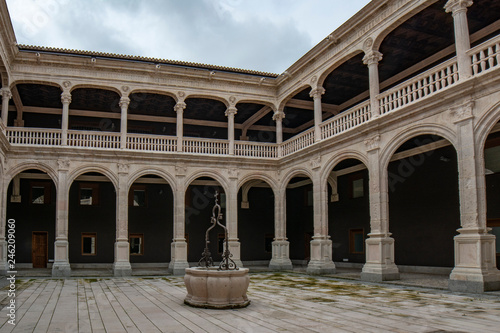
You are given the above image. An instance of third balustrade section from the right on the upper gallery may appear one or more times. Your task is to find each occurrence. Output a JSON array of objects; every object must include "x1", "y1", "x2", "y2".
[{"x1": 320, "y1": 101, "x2": 371, "y2": 140}]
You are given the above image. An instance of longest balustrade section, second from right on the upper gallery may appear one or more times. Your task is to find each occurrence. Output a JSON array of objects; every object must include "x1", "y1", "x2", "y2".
[{"x1": 379, "y1": 59, "x2": 458, "y2": 115}]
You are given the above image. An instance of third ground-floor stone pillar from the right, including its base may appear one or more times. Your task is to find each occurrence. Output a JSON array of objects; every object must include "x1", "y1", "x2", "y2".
[{"x1": 307, "y1": 165, "x2": 336, "y2": 274}]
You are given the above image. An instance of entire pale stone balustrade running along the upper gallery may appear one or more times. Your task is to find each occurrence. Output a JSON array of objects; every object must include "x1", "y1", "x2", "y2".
[{"x1": 1, "y1": 36, "x2": 500, "y2": 158}]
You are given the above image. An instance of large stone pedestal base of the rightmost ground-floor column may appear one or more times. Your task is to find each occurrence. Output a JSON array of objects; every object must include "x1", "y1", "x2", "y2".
[{"x1": 448, "y1": 228, "x2": 500, "y2": 293}]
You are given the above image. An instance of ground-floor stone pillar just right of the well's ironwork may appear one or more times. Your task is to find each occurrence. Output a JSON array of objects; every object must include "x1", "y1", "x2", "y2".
[{"x1": 226, "y1": 170, "x2": 243, "y2": 267}]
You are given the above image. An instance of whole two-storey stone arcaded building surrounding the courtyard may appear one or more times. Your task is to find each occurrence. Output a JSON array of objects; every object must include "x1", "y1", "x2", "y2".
[{"x1": 0, "y1": 0, "x2": 500, "y2": 292}]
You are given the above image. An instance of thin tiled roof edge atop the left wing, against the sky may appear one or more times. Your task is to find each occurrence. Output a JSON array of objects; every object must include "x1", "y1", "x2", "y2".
[{"x1": 18, "y1": 44, "x2": 279, "y2": 78}]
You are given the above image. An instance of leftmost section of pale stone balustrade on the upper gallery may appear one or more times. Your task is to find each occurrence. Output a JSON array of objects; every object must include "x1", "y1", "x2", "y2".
[{"x1": 5, "y1": 127, "x2": 61, "y2": 146}]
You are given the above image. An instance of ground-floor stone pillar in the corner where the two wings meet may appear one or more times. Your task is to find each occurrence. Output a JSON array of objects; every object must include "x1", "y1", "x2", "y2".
[{"x1": 269, "y1": 187, "x2": 293, "y2": 271}]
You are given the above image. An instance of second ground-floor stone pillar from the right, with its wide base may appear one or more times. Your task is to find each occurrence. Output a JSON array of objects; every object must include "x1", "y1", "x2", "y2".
[{"x1": 361, "y1": 135, "x2": 399, "y2": 282}]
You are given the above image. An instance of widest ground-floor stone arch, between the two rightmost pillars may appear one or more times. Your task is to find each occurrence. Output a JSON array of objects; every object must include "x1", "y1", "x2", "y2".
[{"x1": 380, "y1": 123, "x2": 457, "y2": 172}]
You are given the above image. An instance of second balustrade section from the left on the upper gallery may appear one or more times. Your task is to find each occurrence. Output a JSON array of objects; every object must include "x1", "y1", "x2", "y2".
[{"x1": 68, "y1": 131, "x2": 120, "y2": 149}]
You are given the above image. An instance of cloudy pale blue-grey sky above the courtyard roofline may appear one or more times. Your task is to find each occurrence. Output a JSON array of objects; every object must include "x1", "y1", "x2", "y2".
[{"x1": 7, "y1": 0, "x2": 369, "y2": 73}]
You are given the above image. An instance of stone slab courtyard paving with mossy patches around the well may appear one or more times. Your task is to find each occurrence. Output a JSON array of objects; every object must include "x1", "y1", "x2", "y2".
[{"x1": 0, "y1": 273, "x2": 500, "y2": 333}]
